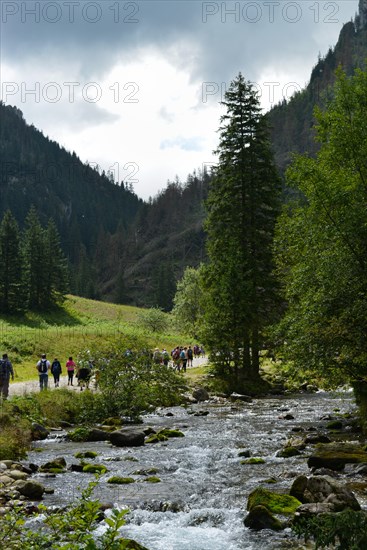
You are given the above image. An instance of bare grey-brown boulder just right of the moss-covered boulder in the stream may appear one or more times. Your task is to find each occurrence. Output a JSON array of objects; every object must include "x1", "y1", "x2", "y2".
[{"x1": 290, "y1": 476, "x2": 361, "y2": 512}]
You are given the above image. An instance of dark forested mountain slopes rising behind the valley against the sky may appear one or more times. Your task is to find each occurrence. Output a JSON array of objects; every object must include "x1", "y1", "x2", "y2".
[{"x1": 0, "y1": 11, "x2": 367, "y2": 310}]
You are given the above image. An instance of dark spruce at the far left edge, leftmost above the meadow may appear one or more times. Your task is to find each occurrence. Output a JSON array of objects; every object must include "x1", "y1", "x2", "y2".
[{"x1": 0, "y1": 210, "x2": 27, "y2": 313}]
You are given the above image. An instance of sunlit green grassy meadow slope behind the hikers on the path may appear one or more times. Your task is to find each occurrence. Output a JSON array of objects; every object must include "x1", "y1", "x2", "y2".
[{"x1": 0, "y1": 295, "x2": 192, "y2": 382}]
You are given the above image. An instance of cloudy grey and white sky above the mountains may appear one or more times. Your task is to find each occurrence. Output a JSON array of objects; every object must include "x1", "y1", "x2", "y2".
[{"x1": 0, "y1": 0, "x2": 358, "y2": 199}]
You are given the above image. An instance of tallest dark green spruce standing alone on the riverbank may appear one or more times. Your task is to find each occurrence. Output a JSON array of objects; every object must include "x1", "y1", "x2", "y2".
[{"x1": 203, "y1": 73, "x2": 280, "y2": 387}]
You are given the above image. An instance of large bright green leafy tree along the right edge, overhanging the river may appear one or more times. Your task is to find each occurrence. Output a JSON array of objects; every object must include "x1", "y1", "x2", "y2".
[{"x1": 277, "y1": 70, "x2": 367, "y2": 385}]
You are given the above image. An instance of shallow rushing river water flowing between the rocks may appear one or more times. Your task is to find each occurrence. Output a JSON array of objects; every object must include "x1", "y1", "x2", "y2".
[{"x1": 29, "y1": 392, "x2": 360, "y2": 550}]
